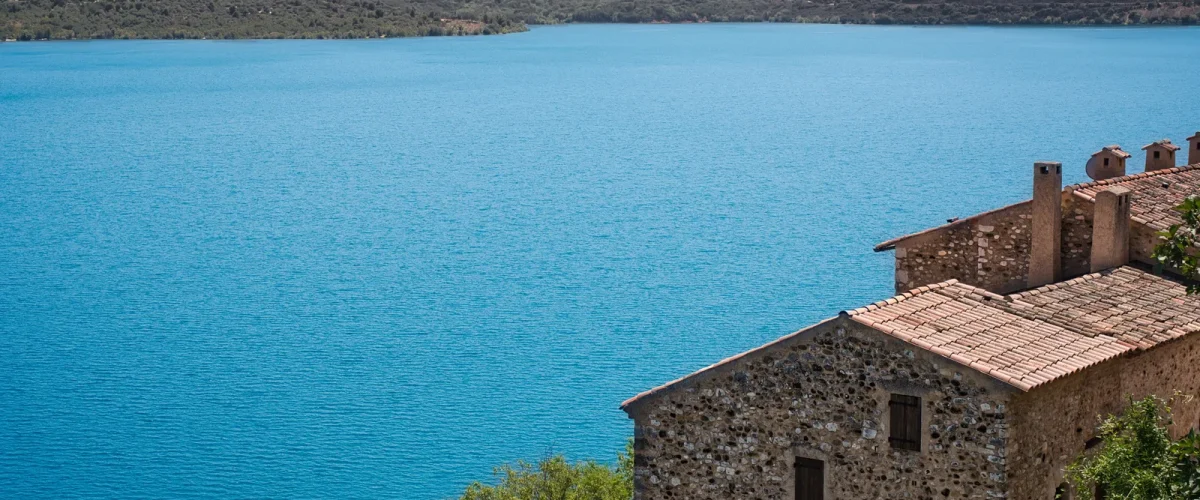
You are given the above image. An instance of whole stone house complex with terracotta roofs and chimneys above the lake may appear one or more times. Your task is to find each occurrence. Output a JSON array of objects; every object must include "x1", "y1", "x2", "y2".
[{"x1": 622, "y1": 137, "x2": 1200, "y2": 500}]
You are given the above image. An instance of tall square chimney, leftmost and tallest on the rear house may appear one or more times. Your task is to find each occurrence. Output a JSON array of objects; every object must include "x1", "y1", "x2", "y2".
[{"x1": 1028, "y1": 162, "x2": 1062, "y2": 288}]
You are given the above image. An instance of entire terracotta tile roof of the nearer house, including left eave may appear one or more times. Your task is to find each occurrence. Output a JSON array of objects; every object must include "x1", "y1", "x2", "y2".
[{"x1": 622, "y1": 266, "x2": 1200, "y2": 410}]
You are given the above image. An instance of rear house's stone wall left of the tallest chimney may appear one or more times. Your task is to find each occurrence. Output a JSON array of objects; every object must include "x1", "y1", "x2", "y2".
[{"x1": 895, "y1": 201, "x2": 1032, "y2": 294}]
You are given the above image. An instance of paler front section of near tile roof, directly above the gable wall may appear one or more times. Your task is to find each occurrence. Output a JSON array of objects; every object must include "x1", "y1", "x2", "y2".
[{"x1": 847, "y1": 279, "x2": 1134, "y2": 391}]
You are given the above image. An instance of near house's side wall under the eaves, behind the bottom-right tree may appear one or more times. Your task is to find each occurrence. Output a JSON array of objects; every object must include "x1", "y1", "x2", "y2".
[{"x1": 1008, "y1": 335, "x2": 1200, "y2": 500}]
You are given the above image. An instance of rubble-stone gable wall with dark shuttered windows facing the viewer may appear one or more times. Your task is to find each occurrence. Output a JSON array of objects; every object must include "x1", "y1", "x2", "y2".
[{"x1": 629, "y1": 317, "x2": 1014, "y2": 500}]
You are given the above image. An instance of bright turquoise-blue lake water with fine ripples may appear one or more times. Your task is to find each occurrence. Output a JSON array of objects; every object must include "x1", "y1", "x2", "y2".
[{"x1": 0, "y1": 24, "x2": 1200, "y2": 499}]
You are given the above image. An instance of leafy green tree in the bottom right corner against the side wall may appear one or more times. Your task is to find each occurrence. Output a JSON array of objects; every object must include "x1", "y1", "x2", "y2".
[{"x1": 1067, "y1": 396, "x2": 1200, "y2": 500}]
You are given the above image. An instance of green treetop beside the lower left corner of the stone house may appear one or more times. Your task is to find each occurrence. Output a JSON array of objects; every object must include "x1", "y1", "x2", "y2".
[{"x1": 460, "y1": 442, "x2": 634, "y2": 500}]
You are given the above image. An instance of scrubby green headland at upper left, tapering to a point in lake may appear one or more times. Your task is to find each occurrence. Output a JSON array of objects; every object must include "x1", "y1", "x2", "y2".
[{"x1": 0, "y1": 0, "x2": 526, "y2": 40}]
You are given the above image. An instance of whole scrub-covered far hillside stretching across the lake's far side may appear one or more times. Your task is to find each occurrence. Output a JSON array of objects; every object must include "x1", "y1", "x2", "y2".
[{"x1": 0, "y1": 0, "x2": 1200, "y2": 40}]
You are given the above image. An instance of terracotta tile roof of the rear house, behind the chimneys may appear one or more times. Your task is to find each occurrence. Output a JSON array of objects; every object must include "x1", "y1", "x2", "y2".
[{"x1": 1067, "y1": 163, "x2": 1200, "y2": 230}]
